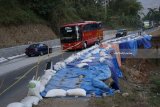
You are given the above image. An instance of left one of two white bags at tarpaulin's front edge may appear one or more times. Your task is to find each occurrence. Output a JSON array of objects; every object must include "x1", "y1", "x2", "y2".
[{"x1": 45, "y1": 89, "x2": 67, "y2": 97}]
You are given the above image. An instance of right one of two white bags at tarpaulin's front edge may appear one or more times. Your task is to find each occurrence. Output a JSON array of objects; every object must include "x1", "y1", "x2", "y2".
[{"x1": 67, "y1": 88, "x2": 86, "y2": 96}]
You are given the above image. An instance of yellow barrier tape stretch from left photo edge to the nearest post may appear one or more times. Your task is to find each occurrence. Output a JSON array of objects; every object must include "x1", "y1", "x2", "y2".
[{"x1": 0, "y1": 66, "x2": 36, "y2": 96}]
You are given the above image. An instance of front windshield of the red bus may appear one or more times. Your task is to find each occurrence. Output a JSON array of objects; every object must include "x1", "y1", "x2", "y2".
[{"x1": 60, "y1": 26, "x2": 80, "y2": 43}]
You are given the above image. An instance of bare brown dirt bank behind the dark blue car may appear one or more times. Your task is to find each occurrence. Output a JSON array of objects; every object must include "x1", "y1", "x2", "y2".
[{"x1": 0, "y1": 24, "x2": 56, "y2": 48}]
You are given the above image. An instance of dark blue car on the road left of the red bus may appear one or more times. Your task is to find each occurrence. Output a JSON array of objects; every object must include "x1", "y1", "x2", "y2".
[{"x1": 25, "y1": 43, "x2": 52, "y2": 57}]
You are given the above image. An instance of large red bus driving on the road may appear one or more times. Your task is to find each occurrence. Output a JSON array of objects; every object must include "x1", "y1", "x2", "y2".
[{"x1": 60, "y1": 21, "x2": 103, "y2": 50}]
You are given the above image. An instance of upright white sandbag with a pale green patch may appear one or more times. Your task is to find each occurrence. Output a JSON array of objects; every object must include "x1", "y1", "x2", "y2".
[{"x1": 28, "y1": 78, "x2": 42, "y2": 99}]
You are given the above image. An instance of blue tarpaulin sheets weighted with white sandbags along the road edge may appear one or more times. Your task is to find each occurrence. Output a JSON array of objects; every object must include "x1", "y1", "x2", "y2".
[{"x1": 41, "y1": 35, "x2": 151, "y2": 97}]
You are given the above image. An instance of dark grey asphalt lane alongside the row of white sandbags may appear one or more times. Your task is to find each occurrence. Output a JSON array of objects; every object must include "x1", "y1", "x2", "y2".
[{"x1": 0, "y1": 52, "x2": 73, "y2": 107}]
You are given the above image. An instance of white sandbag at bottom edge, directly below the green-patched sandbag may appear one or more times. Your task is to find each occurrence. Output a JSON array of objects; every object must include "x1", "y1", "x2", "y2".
[{"x1": 21, "y1": 96, "x2": 40, "y2": 107}]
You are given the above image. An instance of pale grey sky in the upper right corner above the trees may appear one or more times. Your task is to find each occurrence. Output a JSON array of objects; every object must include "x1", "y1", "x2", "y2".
[{"x1": 138, "y1": 0, "x2": 160, "y2": 14}]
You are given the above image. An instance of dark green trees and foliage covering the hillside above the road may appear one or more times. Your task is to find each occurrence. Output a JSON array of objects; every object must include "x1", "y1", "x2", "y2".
[{"x1": 0, "y1": 0, "x2": 142, "y2": 32}]
